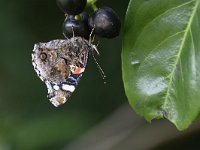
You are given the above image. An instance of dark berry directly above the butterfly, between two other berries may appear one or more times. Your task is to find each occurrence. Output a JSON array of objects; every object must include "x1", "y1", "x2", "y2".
[{"x1": 63, "y1": 17, "x2": 90, "y2": 39}]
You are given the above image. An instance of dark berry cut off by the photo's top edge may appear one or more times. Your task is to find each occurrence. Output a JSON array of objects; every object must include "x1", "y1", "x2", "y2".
[{"x1": 56, "y1": 0, "x2": 87, "y2": 15}]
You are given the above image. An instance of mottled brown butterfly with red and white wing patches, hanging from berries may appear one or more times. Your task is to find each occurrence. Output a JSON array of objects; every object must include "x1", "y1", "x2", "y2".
[{"x1": 32, "y1": 37, "x2": 101, "y2": 107}]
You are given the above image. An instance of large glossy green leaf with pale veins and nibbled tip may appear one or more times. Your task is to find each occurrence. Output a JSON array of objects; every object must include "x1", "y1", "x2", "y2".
[{"x1": 122, "y1": 0, "x2": 200, "y2": 130}]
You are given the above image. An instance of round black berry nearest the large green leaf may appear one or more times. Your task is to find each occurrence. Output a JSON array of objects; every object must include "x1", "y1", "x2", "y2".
[{"x1": 88, "y1": 7, "x2": 121, "y2": 38}]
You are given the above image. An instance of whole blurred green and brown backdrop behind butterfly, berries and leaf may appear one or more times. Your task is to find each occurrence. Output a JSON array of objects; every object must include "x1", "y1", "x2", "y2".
[{"x1": 0, "y1": 0, "x2": 200, "y2": 150}]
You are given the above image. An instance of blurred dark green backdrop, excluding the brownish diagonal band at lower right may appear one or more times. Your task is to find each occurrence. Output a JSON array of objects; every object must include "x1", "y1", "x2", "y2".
[{"x1": 0, "y1": 0, "x2": 128, "y2": 150}]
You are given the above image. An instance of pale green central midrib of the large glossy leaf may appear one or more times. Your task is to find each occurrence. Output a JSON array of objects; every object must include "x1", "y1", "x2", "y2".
[{"x1": 162, "y1": 0, "x2": 199, "y2": 109}]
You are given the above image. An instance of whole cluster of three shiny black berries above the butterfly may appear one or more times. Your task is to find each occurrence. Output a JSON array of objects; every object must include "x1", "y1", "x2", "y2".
[{"x1": 56, "y1": 0, "x2": 121, "y2": 39}]
